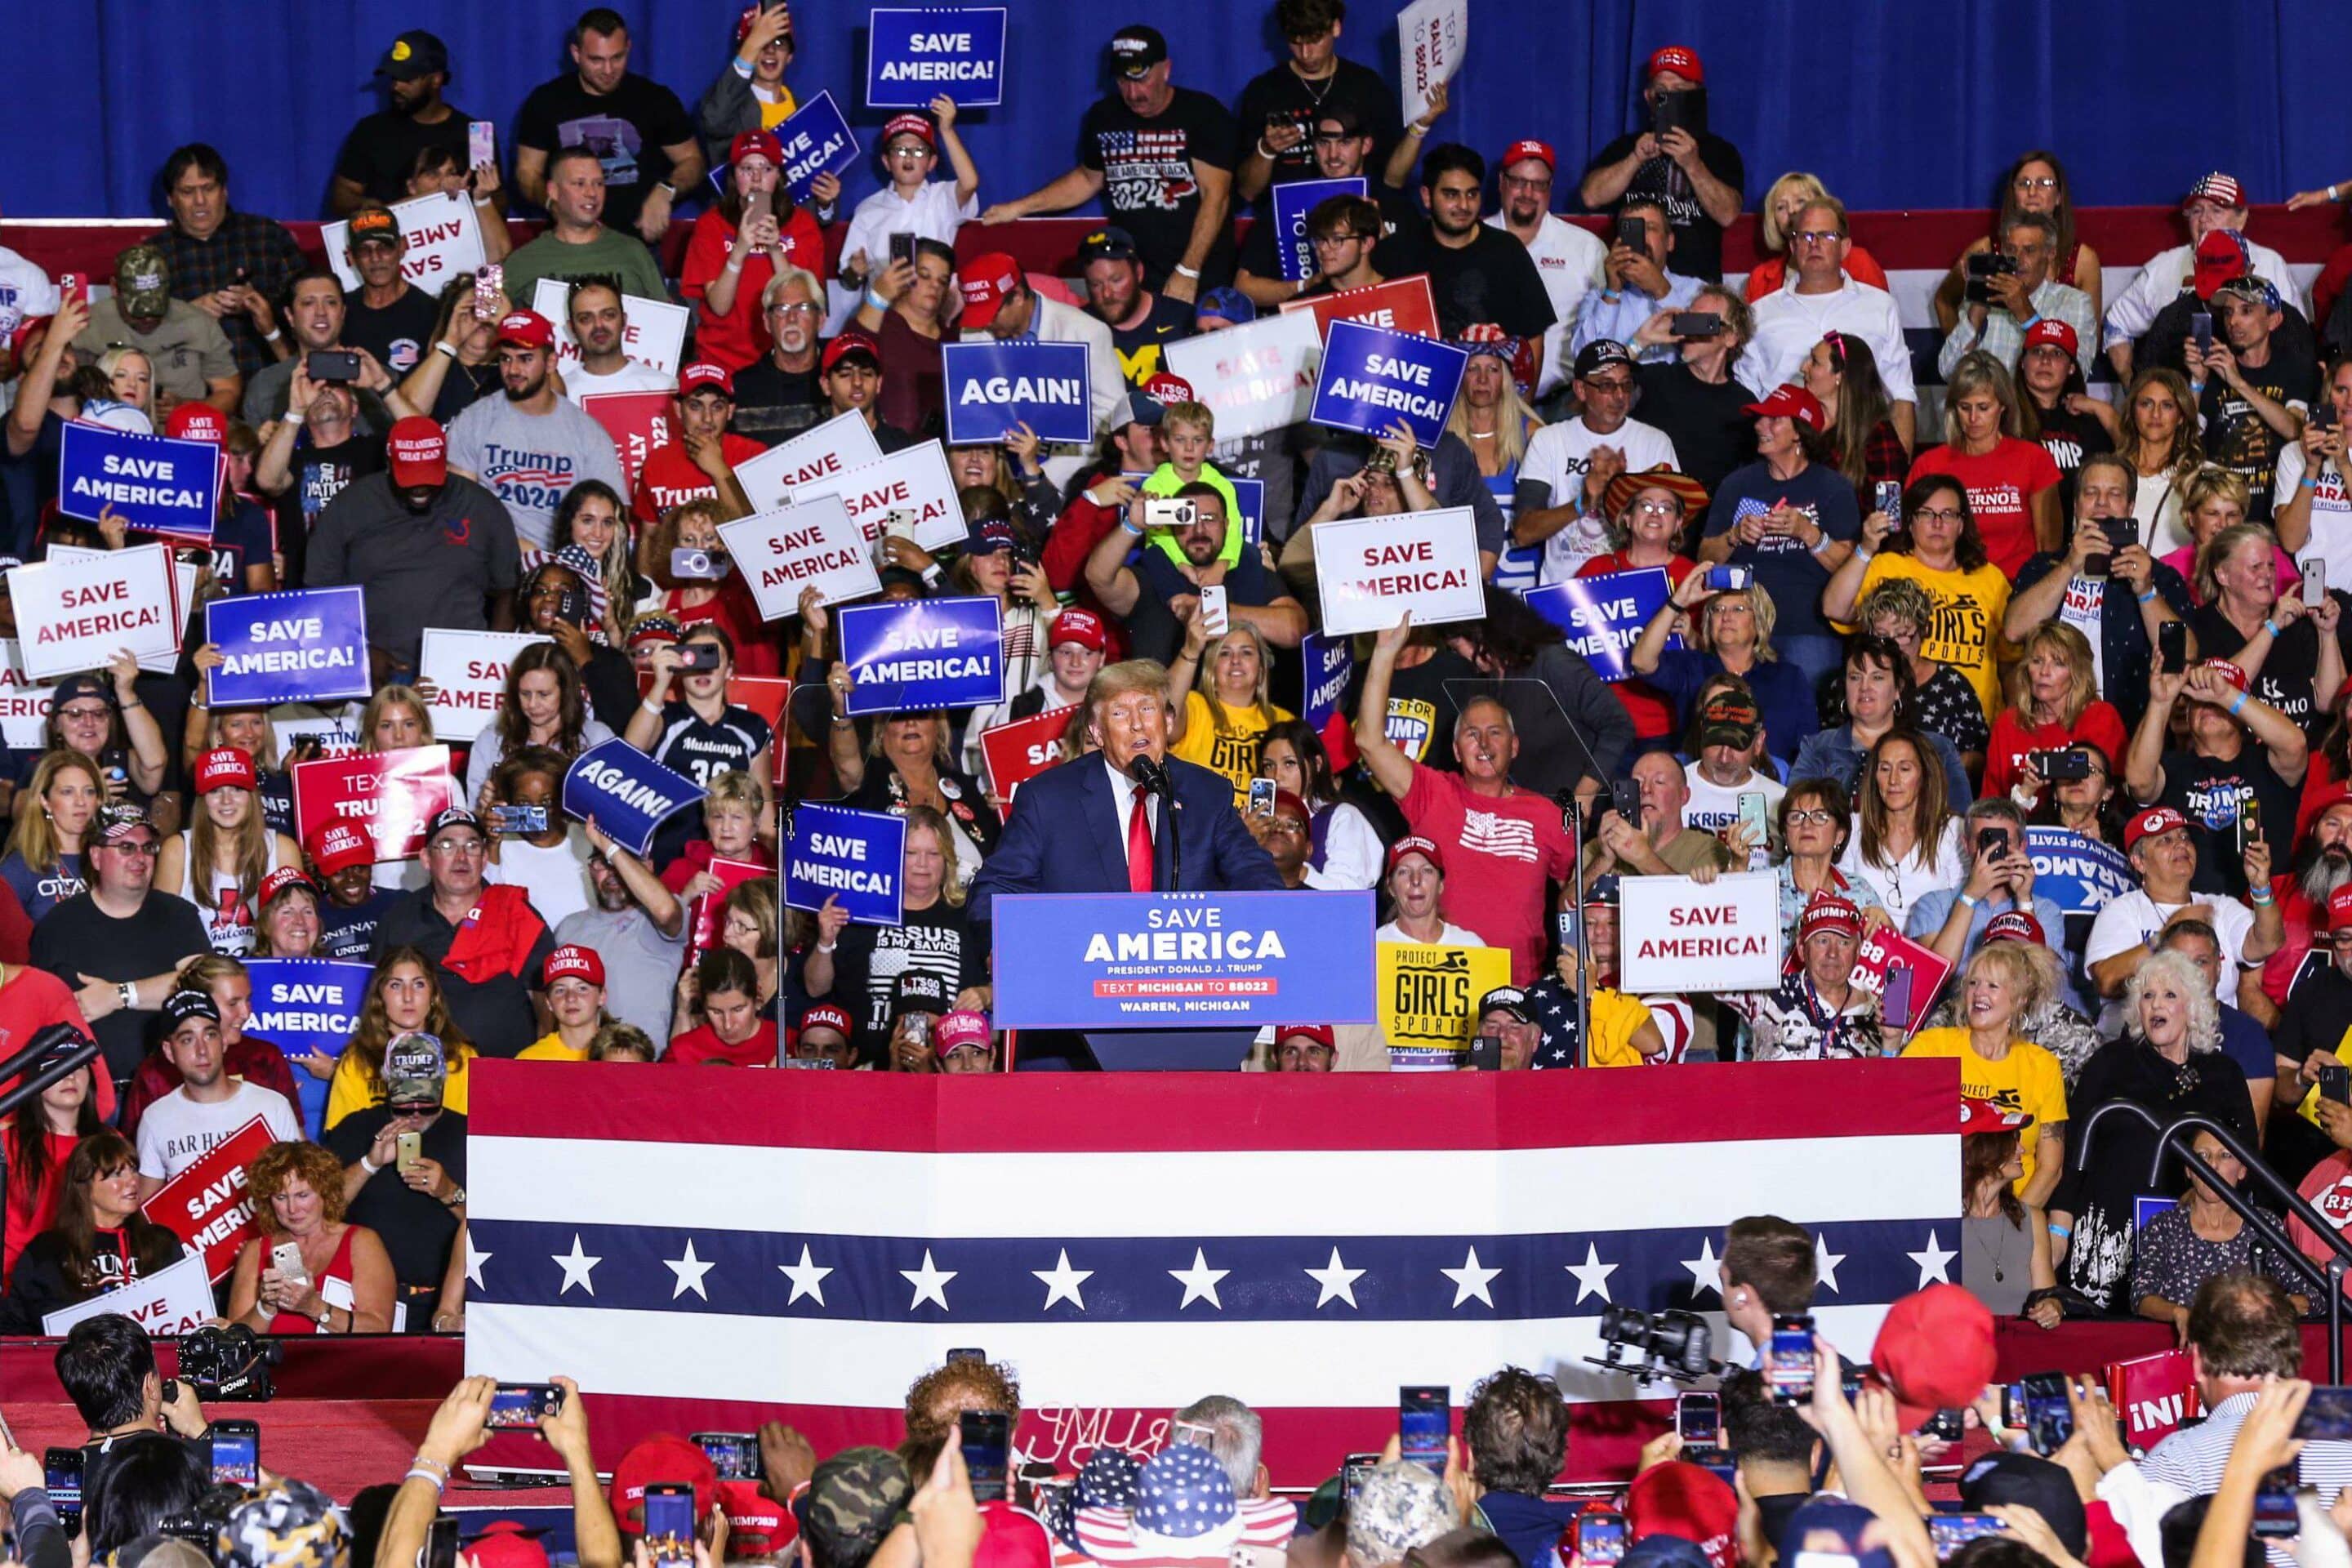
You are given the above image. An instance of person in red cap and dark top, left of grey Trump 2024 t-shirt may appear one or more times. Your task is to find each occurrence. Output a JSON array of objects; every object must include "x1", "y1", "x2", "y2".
[{"x1": 308, "y1": 418, "x2": 522, "y2": 684}]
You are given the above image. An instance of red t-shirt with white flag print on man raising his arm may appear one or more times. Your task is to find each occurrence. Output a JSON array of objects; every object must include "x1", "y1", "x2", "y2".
[{"x1": 1397, "y1": 762, "x2": 1569, "y2": 985}]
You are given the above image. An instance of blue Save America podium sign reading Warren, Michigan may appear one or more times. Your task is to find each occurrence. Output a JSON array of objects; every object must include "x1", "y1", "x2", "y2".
[{"x1": 995, "y1": 891, "x2": 1376, "y2": 1030}]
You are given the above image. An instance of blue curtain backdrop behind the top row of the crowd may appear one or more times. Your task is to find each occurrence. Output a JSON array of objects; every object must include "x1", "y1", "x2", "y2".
[{"x1": 13, "y1": 0, "x2": 2352, "y2": 219}]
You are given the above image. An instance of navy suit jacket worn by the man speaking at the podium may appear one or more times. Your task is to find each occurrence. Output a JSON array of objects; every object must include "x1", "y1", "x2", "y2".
[{"x1": 967, "y1": 752, "x2": 1282, "y2": 921}]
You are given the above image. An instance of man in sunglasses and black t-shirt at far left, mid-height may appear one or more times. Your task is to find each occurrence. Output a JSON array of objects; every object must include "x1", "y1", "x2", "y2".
[{"x1": 33, "y1": 806, "x2": 209, "y2": 1094}]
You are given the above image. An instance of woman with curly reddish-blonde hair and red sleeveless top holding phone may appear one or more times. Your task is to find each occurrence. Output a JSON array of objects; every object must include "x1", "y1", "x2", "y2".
[{"x1": 224, "y1": 1143, "x2": 400, "y2": 1333}]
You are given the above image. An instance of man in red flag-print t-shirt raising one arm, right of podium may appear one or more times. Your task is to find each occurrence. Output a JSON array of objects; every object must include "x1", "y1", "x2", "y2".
[{"x1": 1355, "y1": 611, "x2": 1571, "y2": 985}]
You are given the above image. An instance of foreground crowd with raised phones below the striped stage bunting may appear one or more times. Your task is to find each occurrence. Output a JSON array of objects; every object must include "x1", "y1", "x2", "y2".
[{"x1": 0, "y1": 1259, "x2": 2352, "y2": 1568}]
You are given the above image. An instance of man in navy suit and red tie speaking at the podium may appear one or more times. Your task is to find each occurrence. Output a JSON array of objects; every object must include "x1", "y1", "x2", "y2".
[{"x1": 964, "y1": 658, "x2": 1282, "y2": 1067}]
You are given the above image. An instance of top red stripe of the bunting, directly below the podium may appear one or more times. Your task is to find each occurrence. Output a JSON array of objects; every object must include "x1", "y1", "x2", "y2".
[{"x1": 468, "y1": 1060, "x2": 1959, "y2": 1154}]
